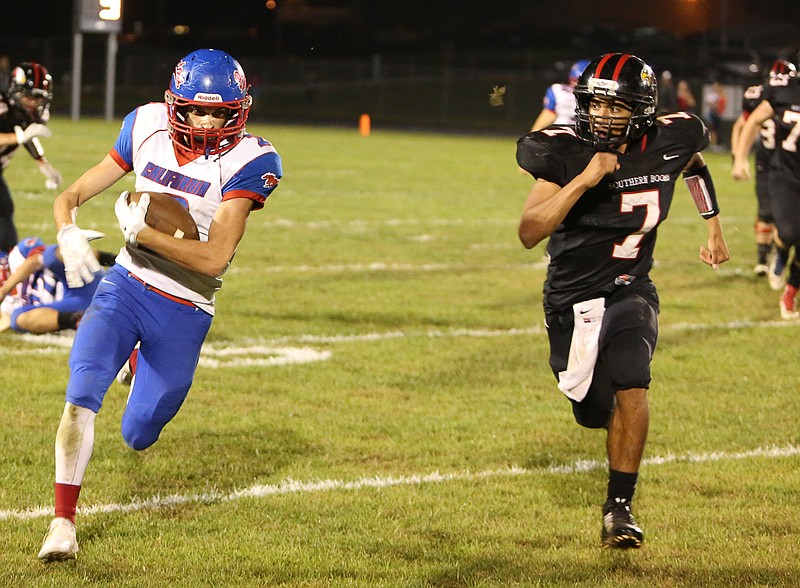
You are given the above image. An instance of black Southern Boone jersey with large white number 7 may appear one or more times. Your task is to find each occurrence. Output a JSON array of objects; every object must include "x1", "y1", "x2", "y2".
[{"x1": 517, "y1": 112, "x2": 709, "y2": 312}]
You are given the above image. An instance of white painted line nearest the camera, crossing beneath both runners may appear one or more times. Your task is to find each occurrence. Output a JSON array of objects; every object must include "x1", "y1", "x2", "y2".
[{"x1": 0, "y1": 445, "x2": 800, "y2": 521}]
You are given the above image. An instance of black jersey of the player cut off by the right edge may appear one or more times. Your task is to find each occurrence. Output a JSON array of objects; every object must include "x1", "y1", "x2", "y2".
[{"x1": 764, "y1": 78, "x2": 800, "y2": 181}]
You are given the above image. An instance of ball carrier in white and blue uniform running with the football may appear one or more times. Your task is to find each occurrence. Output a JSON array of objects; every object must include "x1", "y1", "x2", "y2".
[{"x1": 39, "y1": 49, "x2": 283, "y2": 562}]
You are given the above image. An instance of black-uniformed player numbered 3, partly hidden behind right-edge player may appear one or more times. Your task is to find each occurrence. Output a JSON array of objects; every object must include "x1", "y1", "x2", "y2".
[{"x1": 731, "y1": 59, "x2": 797, "y2": 290}]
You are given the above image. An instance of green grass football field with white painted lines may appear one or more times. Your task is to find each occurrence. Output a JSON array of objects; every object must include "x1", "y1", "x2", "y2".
[{"x1": 0, "y1": 119, "x2": 800, "y2": 588}]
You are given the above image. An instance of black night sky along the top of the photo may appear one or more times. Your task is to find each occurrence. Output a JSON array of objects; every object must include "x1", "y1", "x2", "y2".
[{"x1": 0, "y1": 0, "x2": 800, "y2": 57}]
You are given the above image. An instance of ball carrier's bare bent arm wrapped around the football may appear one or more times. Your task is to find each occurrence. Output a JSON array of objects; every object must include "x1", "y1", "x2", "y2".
[{"x1": 136, "y1": 198, "x2": 252, "y2": 277}]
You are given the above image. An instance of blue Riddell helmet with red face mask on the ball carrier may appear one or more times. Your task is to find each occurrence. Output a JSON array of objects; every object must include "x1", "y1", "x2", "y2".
[{"x1": 164, "y1": 49, "x2": 253, "y2": 157}]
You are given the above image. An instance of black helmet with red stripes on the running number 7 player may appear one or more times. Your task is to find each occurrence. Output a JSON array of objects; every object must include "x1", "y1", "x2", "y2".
[{"x1": 575, "y1": 53, "x2": 658, "y2": 151}]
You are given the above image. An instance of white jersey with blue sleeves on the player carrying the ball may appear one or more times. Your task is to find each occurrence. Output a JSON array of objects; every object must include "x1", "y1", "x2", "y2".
[{"x1": 106, "y1": 103, "x2": 283, "y2": 314}]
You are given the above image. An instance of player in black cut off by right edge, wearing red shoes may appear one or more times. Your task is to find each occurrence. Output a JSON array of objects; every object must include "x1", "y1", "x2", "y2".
[{"x1": 731, "y1": 60, "x2": 800, "y2": 320}]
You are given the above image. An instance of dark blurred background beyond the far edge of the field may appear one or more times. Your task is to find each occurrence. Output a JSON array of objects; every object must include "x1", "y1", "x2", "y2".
[{"x1": 0, "y1": 0, "x2": 800, "y2": 135}]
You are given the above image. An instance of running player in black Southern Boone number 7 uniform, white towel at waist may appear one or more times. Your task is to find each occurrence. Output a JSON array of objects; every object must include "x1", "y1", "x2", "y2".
[{"x1": 517, "y1": 53, "x2": 730, "y2": 549}]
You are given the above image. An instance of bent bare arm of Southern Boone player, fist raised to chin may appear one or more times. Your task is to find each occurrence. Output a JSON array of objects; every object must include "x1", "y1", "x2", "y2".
[{"x1": 518, "y1": 152, "x2": 618, "y2": 249}]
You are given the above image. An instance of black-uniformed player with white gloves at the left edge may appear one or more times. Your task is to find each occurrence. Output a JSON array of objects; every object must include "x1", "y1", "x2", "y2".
[{"x1": 0, "y1": 62, "x2": 61, "y2": 251}]
